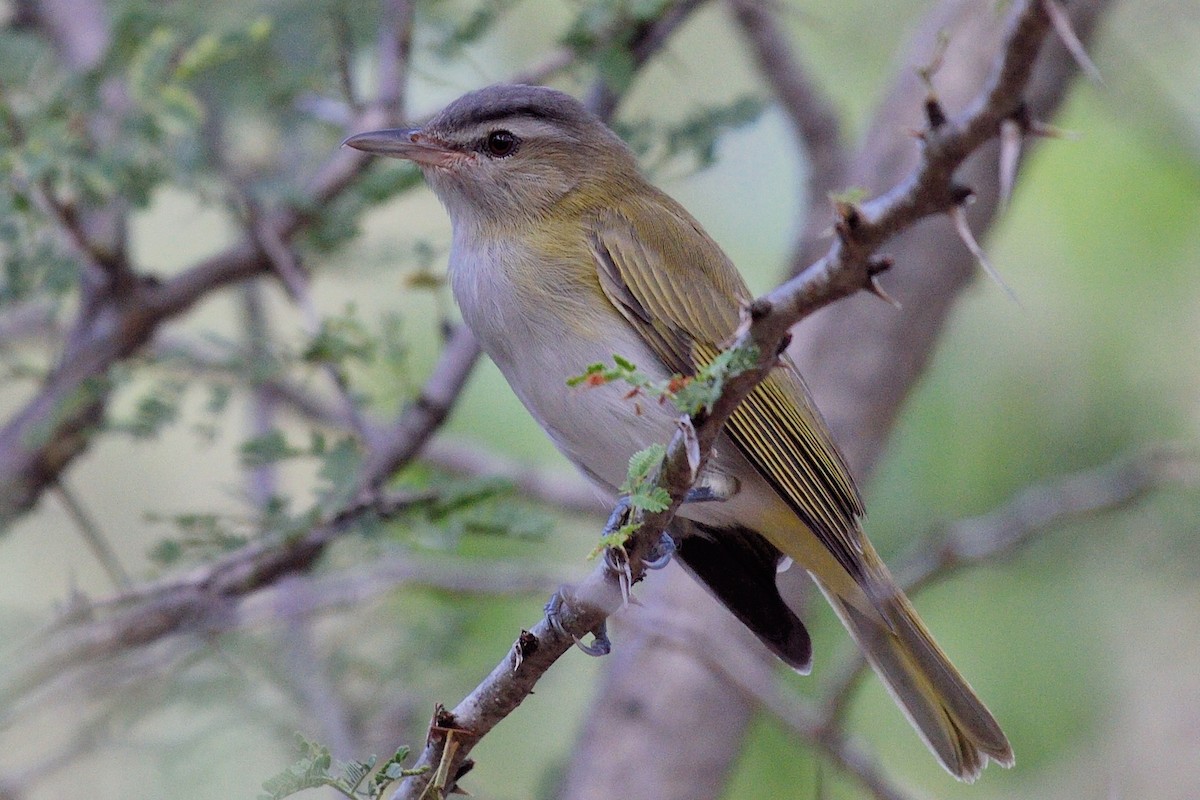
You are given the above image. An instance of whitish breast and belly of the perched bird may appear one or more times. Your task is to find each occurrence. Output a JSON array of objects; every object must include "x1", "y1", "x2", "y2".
[{"x1": 450, "y1": 227, "x2": 781, "y2": 527}]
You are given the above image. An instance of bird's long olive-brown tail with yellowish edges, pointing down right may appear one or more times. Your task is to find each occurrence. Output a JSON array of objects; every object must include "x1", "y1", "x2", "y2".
[{"x1": 817, "y1": 556, "x2": 1014, "y2": 783}]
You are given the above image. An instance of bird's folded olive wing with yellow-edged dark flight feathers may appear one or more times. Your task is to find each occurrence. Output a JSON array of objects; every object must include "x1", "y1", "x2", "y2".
[{"x1": 589, "y1": 194, "x2": 863, "y2": 578}]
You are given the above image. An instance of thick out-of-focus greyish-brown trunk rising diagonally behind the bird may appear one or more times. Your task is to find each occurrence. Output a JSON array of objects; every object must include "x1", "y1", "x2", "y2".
[{"x1": 571, "y1": 0, "x2": 1108, "y2": 800}]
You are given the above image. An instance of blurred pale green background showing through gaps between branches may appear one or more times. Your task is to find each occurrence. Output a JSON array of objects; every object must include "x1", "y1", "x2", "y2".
[{"x1": 0, "y1": 0, "x2": 1200, "y2": 800}]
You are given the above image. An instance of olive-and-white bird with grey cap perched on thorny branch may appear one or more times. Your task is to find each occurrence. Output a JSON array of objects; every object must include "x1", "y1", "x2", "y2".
[{"x1": 346, "y1": 85, "x2": 1013, "y2": 781}]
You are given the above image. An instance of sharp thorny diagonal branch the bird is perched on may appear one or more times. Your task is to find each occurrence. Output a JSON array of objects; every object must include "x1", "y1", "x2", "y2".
[{"x1": 395, "y1": 0, "x2": 1089, "y2": 800}]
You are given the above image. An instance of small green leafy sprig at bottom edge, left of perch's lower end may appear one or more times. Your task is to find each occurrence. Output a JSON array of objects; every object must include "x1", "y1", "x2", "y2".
[{"x1": 258, "y1": 734, "x2": 426, "y2": 800}]
